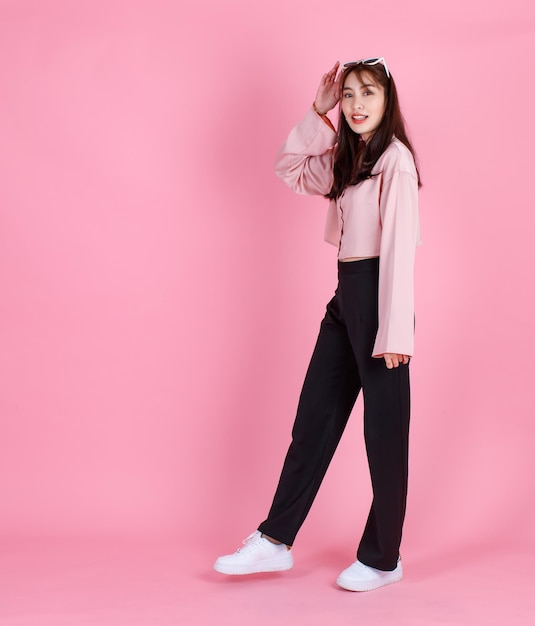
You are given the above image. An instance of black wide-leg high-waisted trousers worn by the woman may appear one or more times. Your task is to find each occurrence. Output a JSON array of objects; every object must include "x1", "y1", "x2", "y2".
[{"x1": 258, "y1": 258, "x2": 410, "y2": 570}]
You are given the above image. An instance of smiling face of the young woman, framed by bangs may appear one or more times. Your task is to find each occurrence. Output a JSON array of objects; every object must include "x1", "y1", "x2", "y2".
[{"x1": 342, "y1": 72, "x2": 386, "y2": 142}]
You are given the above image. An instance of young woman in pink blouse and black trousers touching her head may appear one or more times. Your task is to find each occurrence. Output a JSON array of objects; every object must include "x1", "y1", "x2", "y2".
[{"x1": 214, "y1": 58, "x2": 420, "y2": 591}]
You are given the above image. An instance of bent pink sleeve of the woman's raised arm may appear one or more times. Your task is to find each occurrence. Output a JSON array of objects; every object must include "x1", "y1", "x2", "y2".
[{"x1": 275, "y1": 109, "x2": 337, "y2": 195}]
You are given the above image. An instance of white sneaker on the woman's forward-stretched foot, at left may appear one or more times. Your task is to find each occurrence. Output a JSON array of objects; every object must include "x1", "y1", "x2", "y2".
[{"x1": 214, "y1": 530, "x2": 294, "y2": 574}]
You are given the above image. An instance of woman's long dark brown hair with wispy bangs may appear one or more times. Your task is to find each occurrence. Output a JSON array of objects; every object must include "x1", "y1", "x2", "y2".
[{"x1": 325, "y1": 63, "x2": 422, "y2": 199}]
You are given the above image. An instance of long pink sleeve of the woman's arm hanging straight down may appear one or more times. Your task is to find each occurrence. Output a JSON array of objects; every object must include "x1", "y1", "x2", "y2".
[{"x1": 372, "y1": 169, "x2": 419, "y2": 356}]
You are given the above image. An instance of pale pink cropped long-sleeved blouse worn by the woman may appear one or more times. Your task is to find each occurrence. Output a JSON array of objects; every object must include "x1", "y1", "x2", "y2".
[{"x1": 275, "y1": 109, "x2": 421, "y2": 357}]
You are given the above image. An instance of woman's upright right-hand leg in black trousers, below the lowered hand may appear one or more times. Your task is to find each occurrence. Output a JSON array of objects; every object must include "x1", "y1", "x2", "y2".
[{"x1": 340, "y1": 261, "x2": 410, "y2": 570}]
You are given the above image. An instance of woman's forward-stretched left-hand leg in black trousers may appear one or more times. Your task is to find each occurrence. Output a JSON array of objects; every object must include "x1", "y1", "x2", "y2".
[{"x1": 258, "y1": 296, "x2": 361, "y2": 545}]
